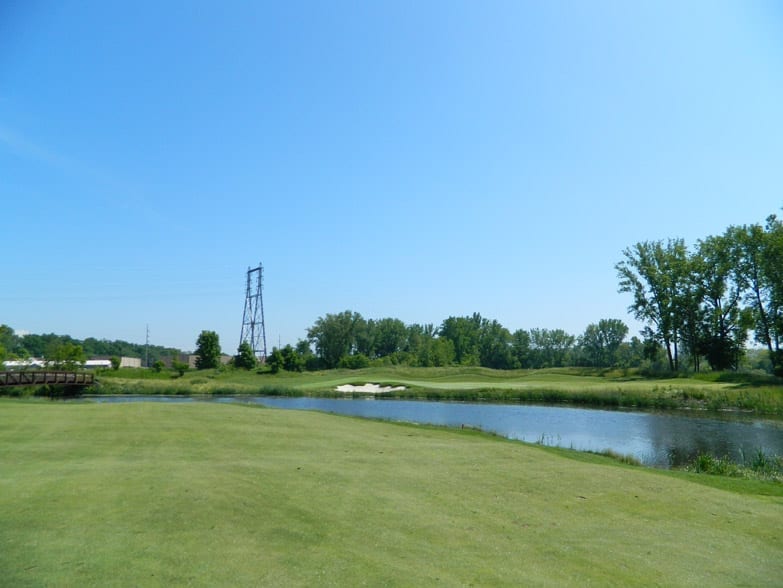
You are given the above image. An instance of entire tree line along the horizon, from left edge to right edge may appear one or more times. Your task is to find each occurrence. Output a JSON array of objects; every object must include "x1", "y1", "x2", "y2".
[{"x1": 0, "y1": 210, "x2": 783, "y2": 375}]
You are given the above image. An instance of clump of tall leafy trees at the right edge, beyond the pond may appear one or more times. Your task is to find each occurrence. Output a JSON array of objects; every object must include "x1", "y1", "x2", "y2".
[{"x1": 615, "y1": 215, "x2": 783, "y2": 375}]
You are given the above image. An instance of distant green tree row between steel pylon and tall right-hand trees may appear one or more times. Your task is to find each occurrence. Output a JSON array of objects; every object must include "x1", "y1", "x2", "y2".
[{"x1": 268, "y1": 310, "x2": 644, "y2": 371}]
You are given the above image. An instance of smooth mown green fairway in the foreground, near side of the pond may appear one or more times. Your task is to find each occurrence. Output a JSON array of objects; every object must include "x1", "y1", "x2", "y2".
[{"x1": 0, "y1": 400, "x2": 783, "y2": 587}]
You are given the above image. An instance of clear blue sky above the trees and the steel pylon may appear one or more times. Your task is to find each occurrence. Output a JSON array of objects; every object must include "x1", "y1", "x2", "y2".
[{"x1": 0, "y1": 0, "x2": 783, "y2": 353}]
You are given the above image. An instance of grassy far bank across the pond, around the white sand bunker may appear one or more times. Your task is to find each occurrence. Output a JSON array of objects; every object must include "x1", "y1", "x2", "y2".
[{"x1": 89, "y1": 367, "x2": 783, "y2": 414}]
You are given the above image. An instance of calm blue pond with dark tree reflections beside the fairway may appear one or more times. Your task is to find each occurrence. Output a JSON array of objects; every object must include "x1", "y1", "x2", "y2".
[{"x1": 87, "y1": 396, "x2": 783, "y2": 467}]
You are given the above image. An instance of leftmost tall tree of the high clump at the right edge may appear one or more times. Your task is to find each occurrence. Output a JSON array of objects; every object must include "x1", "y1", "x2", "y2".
[{"x1": 615, "y1": 239, "x2": 690, "y2": 371}]
